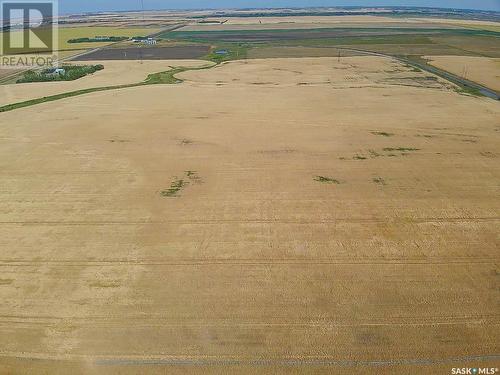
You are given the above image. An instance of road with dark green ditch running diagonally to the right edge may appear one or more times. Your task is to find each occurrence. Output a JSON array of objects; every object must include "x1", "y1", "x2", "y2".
[{"x1": 336, "y1": 47, "x2": 500, "y2": 100}]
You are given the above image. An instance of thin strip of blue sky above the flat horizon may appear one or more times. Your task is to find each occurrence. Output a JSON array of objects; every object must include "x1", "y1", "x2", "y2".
[{"x1": 59, "y1": 0, "x2": 500, "y2": 13}]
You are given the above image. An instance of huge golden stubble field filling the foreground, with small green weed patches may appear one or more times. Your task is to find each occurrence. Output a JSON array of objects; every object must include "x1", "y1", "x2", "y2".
[{"x1": 0, "y1": 57, "x2": 500, "y2": 374}]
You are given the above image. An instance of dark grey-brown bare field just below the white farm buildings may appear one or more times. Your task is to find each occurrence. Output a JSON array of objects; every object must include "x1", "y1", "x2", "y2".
[{"x1": 74, "y1": 46, "x2": 210, "y2": 61}]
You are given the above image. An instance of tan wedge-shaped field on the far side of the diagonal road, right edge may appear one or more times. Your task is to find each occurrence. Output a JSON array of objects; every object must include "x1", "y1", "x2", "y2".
[{"x1": 427, "y1": 56, "x2": 500, "y2": 92}]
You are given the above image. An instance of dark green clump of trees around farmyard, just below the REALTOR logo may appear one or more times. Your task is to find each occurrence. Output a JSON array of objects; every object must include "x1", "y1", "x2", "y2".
[{"x1": 16, "y1": 64, "x2": 104, "y2": 83}]
